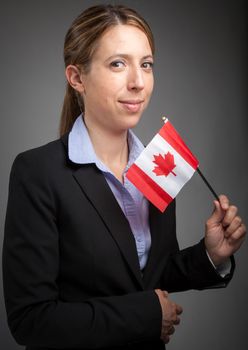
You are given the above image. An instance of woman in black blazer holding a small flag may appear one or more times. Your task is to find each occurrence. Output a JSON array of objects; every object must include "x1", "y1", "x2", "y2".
[{"x1": 3, "y1": 5, "x2": 245, "y2": 350}]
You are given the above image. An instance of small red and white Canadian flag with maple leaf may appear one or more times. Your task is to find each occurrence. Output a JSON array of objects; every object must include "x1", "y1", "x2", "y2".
[{"x1": 126, "y1": 119, "x2": 199, "y2": 212}]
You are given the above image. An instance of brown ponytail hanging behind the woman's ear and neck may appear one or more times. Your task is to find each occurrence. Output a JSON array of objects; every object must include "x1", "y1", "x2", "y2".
[{"x1": 59, "y1": 83, "x2": 84, "y2": 136}]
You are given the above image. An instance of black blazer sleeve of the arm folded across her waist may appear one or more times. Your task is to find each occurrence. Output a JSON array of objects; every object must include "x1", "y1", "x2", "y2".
[{"x1": 3, "y1": 151, "x2": 162, "y2": 348}]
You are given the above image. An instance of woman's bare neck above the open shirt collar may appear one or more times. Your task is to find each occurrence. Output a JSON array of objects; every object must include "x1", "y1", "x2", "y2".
[{"x1": 85, "y1": 119, "x2": 129, "y2": 182}]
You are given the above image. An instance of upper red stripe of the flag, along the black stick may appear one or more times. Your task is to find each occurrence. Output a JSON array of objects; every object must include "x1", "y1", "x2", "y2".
[{"x1": 159, "y1": 121, "x2": 199, "y2": 169}]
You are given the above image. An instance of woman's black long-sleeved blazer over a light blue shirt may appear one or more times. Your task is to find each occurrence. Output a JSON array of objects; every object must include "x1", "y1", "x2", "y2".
[{"x1": 3, "y1": 134, "x2": 234, "y2": 350}]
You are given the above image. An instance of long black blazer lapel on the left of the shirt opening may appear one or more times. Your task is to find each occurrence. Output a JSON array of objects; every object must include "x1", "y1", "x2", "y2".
[{"x1": 73, "y1": 164, "x2": 143, "y2": 289}]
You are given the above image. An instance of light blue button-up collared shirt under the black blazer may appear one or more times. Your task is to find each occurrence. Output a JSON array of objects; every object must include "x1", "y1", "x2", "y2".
[{"x1": 68, "y1": 114, "x2": 151, "y2": 270}]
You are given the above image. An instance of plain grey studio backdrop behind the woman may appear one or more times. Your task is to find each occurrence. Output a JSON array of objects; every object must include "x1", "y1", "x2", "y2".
[{"x1": 0, "y1": 0, "x2": 248, "y2": 350}]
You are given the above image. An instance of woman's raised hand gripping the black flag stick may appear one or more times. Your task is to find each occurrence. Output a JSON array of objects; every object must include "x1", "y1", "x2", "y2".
[{"x1": 205, "y1": 195, "x2": 246, "y2": 266}]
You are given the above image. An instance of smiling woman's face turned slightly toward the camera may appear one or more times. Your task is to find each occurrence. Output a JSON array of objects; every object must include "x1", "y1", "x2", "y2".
[{"x1": 82, "y1": 25, "x2": 153, "y2": 133}]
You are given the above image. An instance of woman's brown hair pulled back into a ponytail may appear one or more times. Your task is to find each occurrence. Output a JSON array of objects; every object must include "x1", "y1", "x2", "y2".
[{"x1": 59, "y1": 5, "x2": 154, "y2": 136}]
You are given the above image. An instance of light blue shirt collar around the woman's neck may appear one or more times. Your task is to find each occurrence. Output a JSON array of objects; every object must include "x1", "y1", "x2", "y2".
[{"x1": 68, "y1": 114, "x2": 144, "y2": 172}]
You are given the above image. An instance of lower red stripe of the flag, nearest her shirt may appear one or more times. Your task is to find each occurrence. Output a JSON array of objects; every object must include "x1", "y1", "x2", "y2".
[{"x1": 126, "y1": 164, "x2": 173, "y2": 212}]
